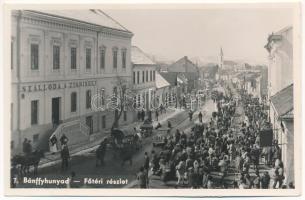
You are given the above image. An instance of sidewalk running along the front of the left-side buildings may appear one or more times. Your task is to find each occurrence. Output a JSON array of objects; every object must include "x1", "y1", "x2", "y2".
[{"x1": 39, "y1": 109, "x2": 184, "y2": 169}]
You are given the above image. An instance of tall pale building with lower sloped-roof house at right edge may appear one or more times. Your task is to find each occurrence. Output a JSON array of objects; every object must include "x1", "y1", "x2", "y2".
[{"x1": 265, "y1": 26, "x2": 295, "y2": 184}]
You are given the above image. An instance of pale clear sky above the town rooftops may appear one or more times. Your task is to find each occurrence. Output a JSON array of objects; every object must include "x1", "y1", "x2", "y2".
[{"x1": 104, "y1": 7, "x2": 293, "y2": 64}]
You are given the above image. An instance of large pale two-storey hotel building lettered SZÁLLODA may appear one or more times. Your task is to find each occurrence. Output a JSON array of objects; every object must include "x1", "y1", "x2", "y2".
[{"x1": 11, "y1": 10, "x2": 133, "y2": 151}]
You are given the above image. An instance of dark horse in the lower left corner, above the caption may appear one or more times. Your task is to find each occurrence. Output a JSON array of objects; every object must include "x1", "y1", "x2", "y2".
[{"x1": 12, "y1": 150, "x2": 44, "y2": 175}]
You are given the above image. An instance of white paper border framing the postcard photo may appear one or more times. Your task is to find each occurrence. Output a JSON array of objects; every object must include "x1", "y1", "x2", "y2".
[{"x1": 0, "y1": 0, "x2": 304, "y2": 197}]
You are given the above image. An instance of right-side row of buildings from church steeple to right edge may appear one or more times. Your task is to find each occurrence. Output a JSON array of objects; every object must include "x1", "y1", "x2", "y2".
[{"x1": 216, "y1": 26, "x2": 295, "y2": 184}]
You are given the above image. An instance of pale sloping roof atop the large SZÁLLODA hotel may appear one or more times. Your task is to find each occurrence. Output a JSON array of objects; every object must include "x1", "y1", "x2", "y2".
[{"x1": 30, "y1": 9, "x2": 130, "y2": 32}]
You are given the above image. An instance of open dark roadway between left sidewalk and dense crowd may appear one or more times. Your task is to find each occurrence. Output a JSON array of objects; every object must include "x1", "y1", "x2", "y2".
[{"x1": 13, "y1": 100, "x2": 214, "y2": 188}]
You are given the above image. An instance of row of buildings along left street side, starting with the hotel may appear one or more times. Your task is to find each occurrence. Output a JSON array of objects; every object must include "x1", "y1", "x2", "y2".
[{"x1": 10, "y1": 10, "x2": 202, "y2": 153}]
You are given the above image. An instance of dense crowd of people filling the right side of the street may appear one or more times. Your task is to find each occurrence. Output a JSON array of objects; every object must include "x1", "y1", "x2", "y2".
[{"x1": 138, "y1": 84, "x2": 290, "y2": 189}]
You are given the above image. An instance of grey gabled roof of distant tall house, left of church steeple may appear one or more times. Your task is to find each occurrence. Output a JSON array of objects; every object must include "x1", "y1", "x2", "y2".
[{"x1": 167, "y1": 56, "x2": 199, "y2": 73}]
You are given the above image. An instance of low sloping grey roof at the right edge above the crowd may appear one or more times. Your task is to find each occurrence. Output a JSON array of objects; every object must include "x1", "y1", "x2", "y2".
[{"x1": 271, "y1": 84, "x2": 293, "y2": 117}]
